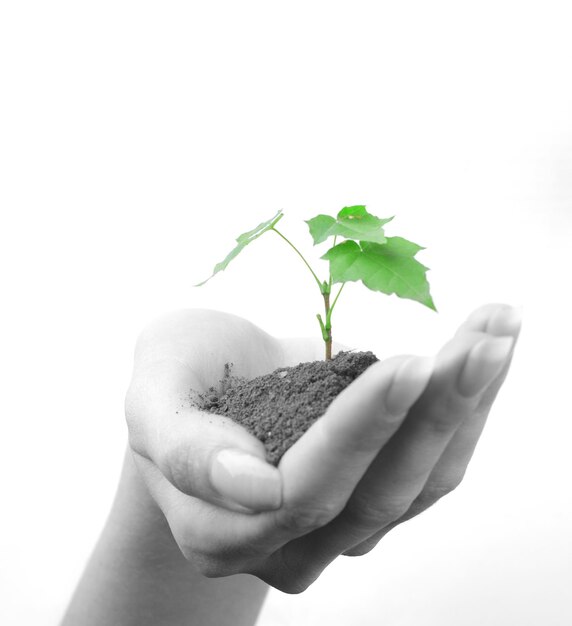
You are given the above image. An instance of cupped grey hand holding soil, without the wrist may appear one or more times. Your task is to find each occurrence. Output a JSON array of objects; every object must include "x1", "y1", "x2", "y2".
[{"x1": 126, "y1": 305, "x2": 519, "y2": 593}]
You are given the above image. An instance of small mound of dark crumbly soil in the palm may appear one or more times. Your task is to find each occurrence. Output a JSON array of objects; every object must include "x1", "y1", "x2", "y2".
[{"x1": 199, "y1": 352, "x2": 378, "y2": 465}]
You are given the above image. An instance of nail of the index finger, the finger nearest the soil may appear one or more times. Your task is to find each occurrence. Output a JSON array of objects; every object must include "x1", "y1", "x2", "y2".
[{"x1": 385, "y1": 356, "x2": 435, "y2": 415}]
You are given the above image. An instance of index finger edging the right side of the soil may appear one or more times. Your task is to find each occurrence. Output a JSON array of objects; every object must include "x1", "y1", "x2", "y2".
[{"x1": 268, "y1": 357, "x2": 433, "y2": 538}]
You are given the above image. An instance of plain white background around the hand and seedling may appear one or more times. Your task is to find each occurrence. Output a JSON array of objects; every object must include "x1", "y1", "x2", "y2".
[{"x1": 0, "y1": 0, "x2": 572, "y2": 626}]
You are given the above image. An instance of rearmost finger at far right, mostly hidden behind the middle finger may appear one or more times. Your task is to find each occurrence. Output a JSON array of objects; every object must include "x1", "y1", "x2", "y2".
[{"x1": 345, "y1": 305, "x2": 522, "y2": 556}]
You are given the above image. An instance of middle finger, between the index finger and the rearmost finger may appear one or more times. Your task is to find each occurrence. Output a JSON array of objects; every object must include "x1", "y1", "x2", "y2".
[{"x1": 294, "y1": 333, "x2": 510, "y2": 559}]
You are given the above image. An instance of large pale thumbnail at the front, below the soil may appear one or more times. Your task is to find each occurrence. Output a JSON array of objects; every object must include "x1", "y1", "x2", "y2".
[{"x1": 210, "y1": 448, "x2": 282, "y2": 511}]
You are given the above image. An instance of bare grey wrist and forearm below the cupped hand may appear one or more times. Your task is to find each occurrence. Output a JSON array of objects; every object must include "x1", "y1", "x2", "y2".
[{"x1": 62, "y1": 449, "x2": 268, "y2": 626}]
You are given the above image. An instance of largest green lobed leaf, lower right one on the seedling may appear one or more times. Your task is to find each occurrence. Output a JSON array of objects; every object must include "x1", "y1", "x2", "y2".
[{"x1": 322, "y1": 237, "x2": 437, "y2": 311}]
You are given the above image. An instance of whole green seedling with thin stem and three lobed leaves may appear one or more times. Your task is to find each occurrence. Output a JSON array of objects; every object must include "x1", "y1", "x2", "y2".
[{"x1": 195, "y1": 205, "x2": 437, "y2": 360}]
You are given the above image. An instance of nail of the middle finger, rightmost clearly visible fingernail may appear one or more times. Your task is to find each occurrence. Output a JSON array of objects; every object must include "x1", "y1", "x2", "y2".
[{"x1": 457, "y1": 337, "x2": 514, "y2": 398}]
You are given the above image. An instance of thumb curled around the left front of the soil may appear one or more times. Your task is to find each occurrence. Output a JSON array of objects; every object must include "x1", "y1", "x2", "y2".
[{"x1": 126, "y1": 360, "x2": 282, "y2": 511}]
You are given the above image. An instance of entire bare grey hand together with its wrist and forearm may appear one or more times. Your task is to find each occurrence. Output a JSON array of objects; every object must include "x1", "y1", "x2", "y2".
[{"x1": 64, "y1": 304, "x2": 520, "y2": 626}]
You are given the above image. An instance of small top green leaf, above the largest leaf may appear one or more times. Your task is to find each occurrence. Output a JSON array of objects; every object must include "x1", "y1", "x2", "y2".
[{"x1": 306, "y1": 205, "x2": 393, "y2": 245}]
